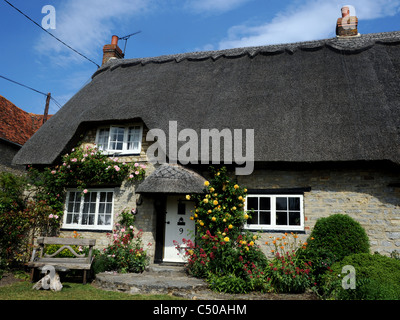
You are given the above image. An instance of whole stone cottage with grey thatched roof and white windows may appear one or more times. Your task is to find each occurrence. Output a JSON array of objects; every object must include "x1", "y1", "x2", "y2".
[{"x1": 14, "y1": 15, "x2": 400, "y2": 262}]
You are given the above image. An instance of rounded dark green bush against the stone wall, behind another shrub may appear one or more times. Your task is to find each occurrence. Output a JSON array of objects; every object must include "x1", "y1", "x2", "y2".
[{"x1": 307, "y1": 214, "x2": 370, "y2": 261}]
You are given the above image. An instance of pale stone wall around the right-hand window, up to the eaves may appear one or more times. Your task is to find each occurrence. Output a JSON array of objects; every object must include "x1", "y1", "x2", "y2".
[{"x1": 238, "y1": 167, "x2": 400, "y2": 254}]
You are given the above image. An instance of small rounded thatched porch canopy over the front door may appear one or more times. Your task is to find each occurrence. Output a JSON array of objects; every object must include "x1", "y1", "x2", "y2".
[{"x1": 136, "y1": 164, "x2": 205, "y2": 194}]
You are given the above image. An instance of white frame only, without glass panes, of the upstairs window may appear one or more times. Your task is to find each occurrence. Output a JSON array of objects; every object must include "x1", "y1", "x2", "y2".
[{"x1": 96, "y1": 123, "x2": 143, "y2": 155}]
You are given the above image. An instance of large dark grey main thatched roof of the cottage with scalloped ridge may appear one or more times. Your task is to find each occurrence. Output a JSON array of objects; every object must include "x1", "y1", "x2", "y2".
[{"x1": 14, "y1": 32, "x2": 400, "y2": 164}]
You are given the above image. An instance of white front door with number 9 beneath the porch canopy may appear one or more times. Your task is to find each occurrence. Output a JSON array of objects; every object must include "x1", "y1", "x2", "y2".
[{"x1": 163, "y1": 196, "x2": 195, "y2": 262}]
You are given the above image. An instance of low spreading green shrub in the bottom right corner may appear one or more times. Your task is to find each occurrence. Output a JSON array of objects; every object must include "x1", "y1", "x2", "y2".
[{"x1": 323, "y1": 253, "x2": 400, "y2": 300}]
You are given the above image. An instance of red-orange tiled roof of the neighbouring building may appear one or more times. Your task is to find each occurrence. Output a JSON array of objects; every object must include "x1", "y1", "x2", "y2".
[{"x1": 0, "y1": 95, "x2": 50, "y2": 145}]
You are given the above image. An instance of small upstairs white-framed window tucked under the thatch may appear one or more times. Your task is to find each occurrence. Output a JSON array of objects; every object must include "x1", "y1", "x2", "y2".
[{"x1": 96, "y1": 124, "x2": 142, "y2": 154}]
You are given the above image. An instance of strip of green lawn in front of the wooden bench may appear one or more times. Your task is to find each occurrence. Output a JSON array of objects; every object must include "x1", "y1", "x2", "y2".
[{"x1": 0, "y1": 272, "x2": 184, "y2": 300}]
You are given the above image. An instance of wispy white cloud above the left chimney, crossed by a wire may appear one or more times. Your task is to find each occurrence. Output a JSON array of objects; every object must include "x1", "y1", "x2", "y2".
[{"x1": 35, "y1": 0, "x2": 152, "y2": 65}]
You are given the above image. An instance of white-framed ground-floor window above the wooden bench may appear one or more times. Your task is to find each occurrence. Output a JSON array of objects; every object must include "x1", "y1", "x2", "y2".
[{"x1": 62, "y1": 189, "x2": 114, "y2": 230}]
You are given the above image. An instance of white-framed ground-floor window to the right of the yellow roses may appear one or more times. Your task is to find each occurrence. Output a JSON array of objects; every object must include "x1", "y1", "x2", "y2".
[{"x1": 245, "y1": 194, "x2": 304, "y2": 231}]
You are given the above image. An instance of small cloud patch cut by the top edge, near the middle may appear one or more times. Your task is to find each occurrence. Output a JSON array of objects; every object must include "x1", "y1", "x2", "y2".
[{"x1": 185, "y1": 0, "x2": 249, "y2": 13}]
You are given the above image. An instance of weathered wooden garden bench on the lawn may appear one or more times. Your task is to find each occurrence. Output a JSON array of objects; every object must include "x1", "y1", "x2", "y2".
[{"x1": 28, "y1": 237, "x2": 96, "y2": 284}]
